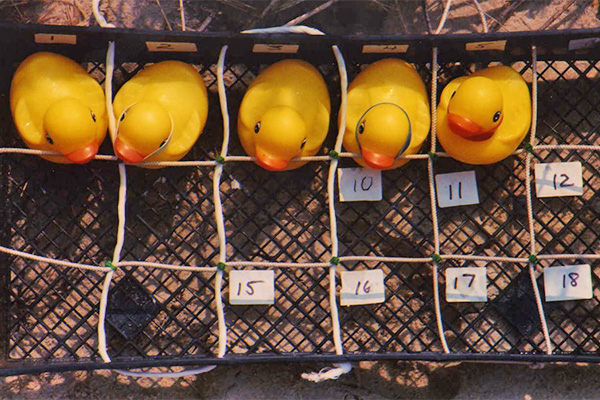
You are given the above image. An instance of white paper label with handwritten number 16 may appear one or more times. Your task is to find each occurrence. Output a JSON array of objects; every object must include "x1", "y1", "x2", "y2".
[{"x1": 340, "y1": 269, "x2": 385, "y2": 306}]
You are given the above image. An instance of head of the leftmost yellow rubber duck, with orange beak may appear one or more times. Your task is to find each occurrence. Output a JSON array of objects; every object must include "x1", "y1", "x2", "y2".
[{"x1": 44, "y1": 98, "x2": 100, "y2": 164}]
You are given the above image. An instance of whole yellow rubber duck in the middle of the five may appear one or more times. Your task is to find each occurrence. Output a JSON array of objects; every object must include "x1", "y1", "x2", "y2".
[{"x1": 238, "y1": 60, "x2": 331, "y2": 171}]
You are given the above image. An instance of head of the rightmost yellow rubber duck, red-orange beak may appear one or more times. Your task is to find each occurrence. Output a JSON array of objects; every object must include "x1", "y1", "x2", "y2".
[{"x1": 448, "y1": 76, "x2": 503, "y2": 141}]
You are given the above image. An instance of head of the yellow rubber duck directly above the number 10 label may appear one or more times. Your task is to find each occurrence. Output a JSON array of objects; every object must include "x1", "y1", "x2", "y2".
[{"x1": 355, "y1": 103, "x2": 411, "y2": 170}]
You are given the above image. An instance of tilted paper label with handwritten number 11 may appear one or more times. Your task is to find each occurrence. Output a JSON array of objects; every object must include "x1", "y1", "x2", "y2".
[{"x1": 435, "y1": 171, "x2": 479, "y2": 208}]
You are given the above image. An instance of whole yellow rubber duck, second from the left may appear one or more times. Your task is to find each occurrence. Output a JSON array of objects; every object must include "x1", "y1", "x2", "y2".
[{"x1": 113, "y1": 61, "x2": 208, "y2": 168}]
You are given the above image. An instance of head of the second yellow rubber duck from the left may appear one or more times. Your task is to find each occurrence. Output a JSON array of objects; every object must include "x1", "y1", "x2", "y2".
[{"x1": 114, "y1": 100, "x2": 173, "y2": 164}]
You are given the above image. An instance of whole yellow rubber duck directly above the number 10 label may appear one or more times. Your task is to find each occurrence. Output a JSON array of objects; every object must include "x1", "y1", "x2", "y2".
[{"x1": 344, "y1": 58, "x2": 431, "y2": 170}]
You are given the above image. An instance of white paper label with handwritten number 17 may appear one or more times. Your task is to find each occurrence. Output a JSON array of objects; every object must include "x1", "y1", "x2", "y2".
[{"x1": 446, "y1": 267, "x2": 487, "y2": 303}]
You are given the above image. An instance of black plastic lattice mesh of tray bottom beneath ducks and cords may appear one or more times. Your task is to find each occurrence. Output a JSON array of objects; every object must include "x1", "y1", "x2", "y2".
[{"x1": 2, "y1": 43, "x2": 600, "y2": 372}]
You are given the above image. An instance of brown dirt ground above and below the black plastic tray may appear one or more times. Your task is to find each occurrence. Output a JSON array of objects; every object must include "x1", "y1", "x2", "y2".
[{"x1": 0, "y1": 0, "x2": 600, "y2": 400}]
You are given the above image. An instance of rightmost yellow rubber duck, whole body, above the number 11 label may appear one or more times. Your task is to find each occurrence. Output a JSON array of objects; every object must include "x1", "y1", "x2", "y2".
[{"x1": 437, "y1": 65, "x2": 531, "y2": 165}]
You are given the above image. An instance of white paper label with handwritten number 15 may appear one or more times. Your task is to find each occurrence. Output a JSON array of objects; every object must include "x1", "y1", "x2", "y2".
[{"x1": 229, "y1": 270, "x2": 275, "y2": 305}]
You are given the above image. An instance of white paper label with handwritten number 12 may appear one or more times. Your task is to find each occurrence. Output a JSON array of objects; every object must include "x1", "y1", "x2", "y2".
[{"x1": 535, "y1": 161, "x2": 583, "y2": 197}]
